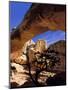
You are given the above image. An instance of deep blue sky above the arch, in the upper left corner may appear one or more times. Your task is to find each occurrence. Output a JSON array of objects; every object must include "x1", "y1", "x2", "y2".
[{"x1": 9, "y1": 1, "x2": 32, "y2": 31}]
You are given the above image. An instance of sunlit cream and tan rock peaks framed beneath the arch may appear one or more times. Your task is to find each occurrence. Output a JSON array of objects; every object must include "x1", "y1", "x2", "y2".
[{"x1": 15, "y1": 40, "x2": 47, "y2": 64}]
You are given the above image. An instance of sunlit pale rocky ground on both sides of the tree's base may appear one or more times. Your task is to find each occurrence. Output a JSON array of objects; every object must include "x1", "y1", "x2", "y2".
[{"x1": 10, "y1": 63, "x2": 56, "y2": 88}]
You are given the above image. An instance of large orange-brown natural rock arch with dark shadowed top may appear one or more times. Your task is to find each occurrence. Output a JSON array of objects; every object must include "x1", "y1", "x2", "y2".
[{"x1": 10, "y1": 3, "x2": 66, "y2": 52}]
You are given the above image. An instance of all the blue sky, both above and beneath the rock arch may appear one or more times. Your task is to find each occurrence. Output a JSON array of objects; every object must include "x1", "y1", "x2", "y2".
[{"x1": 9, "y1": 1, "x2": 65, "y2": 46}]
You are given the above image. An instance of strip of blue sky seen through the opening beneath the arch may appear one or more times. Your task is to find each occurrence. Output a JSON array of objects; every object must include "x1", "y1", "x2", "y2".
[{"x1": 32, "y1": 30, "x2": 65, "y2": 46}]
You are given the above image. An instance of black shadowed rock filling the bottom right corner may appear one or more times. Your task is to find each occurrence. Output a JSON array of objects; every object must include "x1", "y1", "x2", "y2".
[{"x1": 46, "y1": 72, "x2": 66, "y2": 86}]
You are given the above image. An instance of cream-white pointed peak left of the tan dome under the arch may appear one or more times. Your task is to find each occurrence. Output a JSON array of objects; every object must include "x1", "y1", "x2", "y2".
[{"x1": 21, "y1": 40, "x2": 35, "y2": 62}]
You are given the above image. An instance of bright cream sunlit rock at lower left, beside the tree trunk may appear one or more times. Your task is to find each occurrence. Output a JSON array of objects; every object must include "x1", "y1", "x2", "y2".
[{"x1": 10, "y1": 63, "x2": 28, "y2": 87}]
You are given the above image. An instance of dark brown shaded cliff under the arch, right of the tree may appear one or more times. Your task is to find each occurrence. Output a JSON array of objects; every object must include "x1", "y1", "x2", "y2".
[{"x1": 48, "y1": 40, "x2": 66, "y2": 72}]
